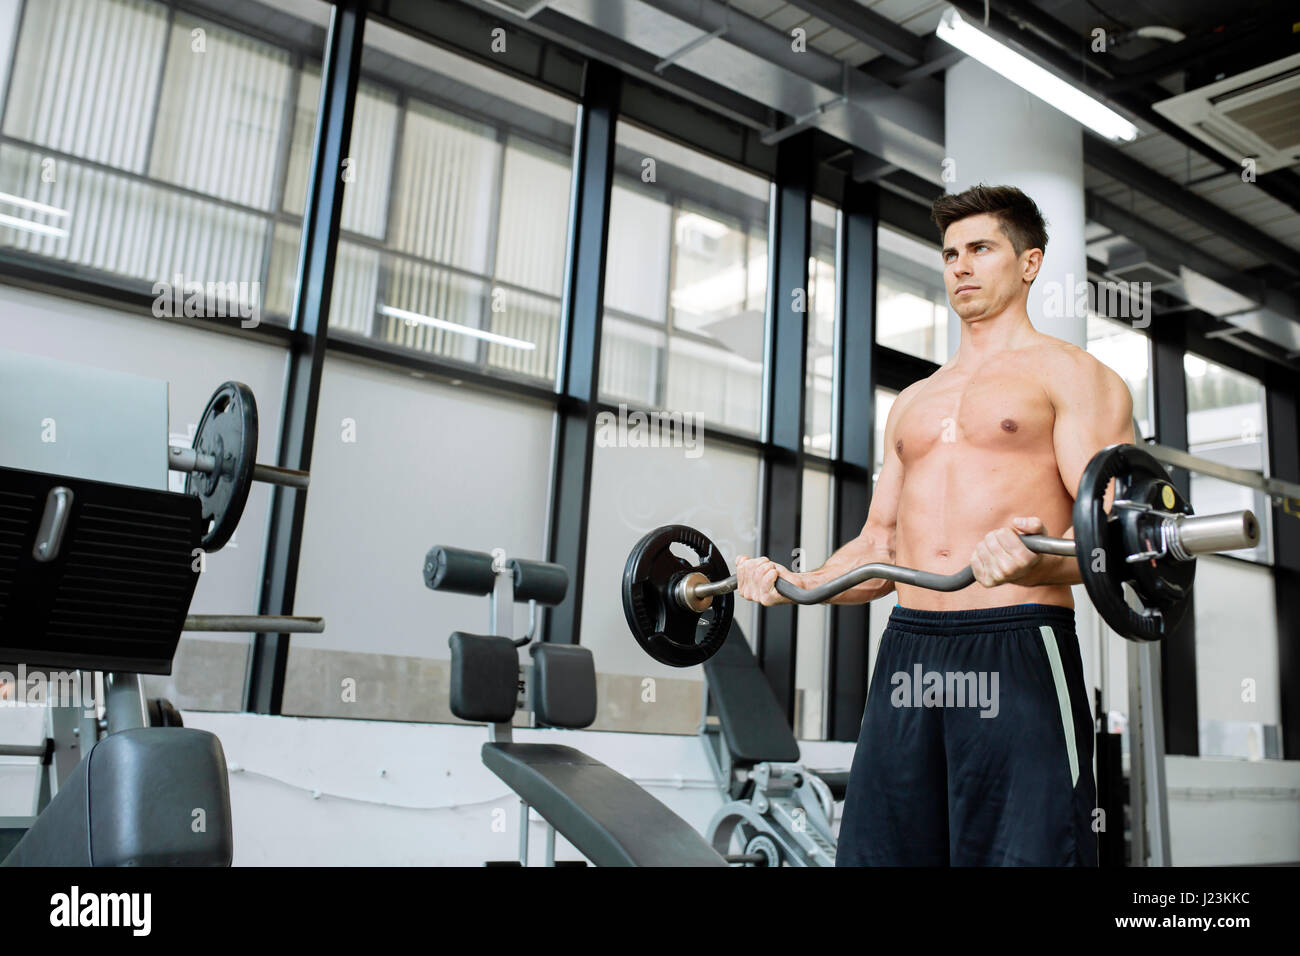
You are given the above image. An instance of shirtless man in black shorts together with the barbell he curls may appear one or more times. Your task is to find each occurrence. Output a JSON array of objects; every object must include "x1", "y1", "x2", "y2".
[{"x1": 624, "y1": 187, "x2": 1258, "y2": 866}]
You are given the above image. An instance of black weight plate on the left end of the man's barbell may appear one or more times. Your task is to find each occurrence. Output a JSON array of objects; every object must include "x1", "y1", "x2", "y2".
[{"x1": 623, "y1": 524, "x2": 736, "y2": 667}]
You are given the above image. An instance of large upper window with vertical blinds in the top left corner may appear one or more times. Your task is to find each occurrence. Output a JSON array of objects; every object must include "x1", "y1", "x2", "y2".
[{"x1": 0, "y1": 0, "x2": 330, "y2": 316}]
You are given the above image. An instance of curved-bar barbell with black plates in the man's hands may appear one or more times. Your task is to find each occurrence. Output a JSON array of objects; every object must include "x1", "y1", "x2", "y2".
[{"x1": 623, "y1": 445, "x2": 1260, "y2": 667}]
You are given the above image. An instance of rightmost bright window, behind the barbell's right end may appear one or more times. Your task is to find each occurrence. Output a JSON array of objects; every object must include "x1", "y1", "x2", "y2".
[{"x1": 1183, "y1": 352, "x2": 1271, "y2": 563}]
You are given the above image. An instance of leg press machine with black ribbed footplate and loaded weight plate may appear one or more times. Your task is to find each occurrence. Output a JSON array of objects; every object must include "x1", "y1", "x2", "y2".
[{"x1": 0, "y1": 352, "x2": 325, "y2": 866}]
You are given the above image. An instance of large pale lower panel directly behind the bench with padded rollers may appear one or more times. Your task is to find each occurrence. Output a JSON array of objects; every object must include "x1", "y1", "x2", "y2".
[{"x1": 283, "y1": 356, "x2": 553, "y2": 722}]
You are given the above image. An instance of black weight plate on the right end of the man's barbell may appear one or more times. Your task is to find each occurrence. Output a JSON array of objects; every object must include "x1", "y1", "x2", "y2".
[{"x1": 1074, "y1": 445, "x2": 1196, "y2": 643}]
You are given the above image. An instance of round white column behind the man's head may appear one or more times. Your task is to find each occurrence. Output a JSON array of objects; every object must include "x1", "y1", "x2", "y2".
[{"x1": 944, "y1": 57, "x2": 1088, "y2": 356}]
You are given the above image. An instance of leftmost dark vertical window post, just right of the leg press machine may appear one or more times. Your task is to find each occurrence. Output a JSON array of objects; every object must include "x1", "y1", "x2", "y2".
[{"x1": 244, "y1": 0, "x2": 365, "y2": 714}]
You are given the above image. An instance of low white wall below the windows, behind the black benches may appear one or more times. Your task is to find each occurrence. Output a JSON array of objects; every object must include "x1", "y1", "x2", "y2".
[{"x1": 172, "y1": 714, "x2": 853, "y2": 866}]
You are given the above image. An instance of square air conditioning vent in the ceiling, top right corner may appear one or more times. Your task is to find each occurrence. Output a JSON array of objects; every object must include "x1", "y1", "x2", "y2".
[{"x1": 1154, "y1": 53, "x2": 1300, "y2": 173}]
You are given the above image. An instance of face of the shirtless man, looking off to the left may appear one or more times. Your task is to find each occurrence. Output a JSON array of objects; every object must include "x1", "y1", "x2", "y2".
[{"x1": 943, "y1": 213, "x2": 1043, "y2": 321}]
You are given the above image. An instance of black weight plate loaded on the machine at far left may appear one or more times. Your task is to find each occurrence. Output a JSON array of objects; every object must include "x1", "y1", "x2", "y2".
[{"x1": 185, "y1": 381, "x2": 257, "y2": 551}]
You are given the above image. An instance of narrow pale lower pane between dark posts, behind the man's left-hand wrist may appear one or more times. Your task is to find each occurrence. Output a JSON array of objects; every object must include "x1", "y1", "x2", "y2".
[{"x1": 776, "y1": 468, "x2": 835, "y2": 740}]
